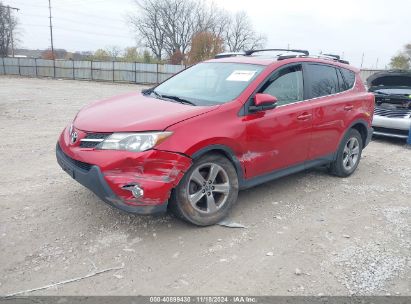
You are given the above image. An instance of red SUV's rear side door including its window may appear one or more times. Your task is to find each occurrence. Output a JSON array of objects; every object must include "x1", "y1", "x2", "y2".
[{"x1": 304, "y1": 63, "x2": 355, "y2": 160}]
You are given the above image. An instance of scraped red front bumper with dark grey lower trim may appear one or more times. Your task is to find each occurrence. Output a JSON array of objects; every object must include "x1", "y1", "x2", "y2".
[{"x1": 56, "y1": 143, "x2": 191, "y2": 214}]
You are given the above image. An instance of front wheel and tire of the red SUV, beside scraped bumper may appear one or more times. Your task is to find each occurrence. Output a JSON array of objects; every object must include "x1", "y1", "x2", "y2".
[{"x1": 170, "y1": 154, "x2": 238, "y2": 226}]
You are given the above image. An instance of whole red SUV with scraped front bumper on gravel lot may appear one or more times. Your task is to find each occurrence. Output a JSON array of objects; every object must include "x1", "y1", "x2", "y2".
[{"x1": 56, "y1": 49, "x2": 374, "y2": 226}]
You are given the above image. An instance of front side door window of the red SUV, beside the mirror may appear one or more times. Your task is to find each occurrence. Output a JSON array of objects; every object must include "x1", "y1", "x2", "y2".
[{"x1": 260, "y1": 65, "x2": 304, "y2": 106}]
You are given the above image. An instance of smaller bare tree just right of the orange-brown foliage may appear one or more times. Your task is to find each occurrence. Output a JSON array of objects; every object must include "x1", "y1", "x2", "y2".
[{"x1": 224, "y1": 11, "x2": 266, "y2": 52}]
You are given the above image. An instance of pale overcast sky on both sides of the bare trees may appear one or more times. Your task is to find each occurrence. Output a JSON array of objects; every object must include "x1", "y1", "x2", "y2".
[{"x1": 0, "y1": 0, "x2": 411, "y2": 68}]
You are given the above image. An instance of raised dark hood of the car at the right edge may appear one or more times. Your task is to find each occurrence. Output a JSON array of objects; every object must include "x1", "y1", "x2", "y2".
[{"x1": 367, "y1": 71, "x2": 411, "y2": 92}]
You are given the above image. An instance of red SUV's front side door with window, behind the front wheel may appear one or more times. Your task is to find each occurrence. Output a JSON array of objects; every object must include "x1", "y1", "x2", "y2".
[{"x1": 243, "y1": 64, "x2": 312, "y2": 178}]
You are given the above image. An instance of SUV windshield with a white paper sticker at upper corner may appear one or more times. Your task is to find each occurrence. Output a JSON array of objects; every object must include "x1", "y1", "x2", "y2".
[{"x1": 153, "y1": 62, "x2": 264, "y2": 106}]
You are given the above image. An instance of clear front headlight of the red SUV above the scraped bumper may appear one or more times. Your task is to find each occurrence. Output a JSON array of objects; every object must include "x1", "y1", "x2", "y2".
[{"x1": 97, "y1": 132, "x2": 172, "y2": 152}]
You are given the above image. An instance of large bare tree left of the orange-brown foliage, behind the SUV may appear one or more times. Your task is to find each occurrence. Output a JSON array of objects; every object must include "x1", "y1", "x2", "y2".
[{"x1": 129, "y1": 0, "x2": 228, "y2": 59}]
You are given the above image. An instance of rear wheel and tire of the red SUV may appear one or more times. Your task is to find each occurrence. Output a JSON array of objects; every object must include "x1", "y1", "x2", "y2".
[{"x1": 329, "y1": 129, "x2": 363, "y2": 177}]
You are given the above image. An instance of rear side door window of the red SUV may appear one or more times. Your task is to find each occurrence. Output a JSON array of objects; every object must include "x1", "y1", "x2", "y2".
[{"x1": 307, "y1": 64, "x2": 340, "y2": 98}]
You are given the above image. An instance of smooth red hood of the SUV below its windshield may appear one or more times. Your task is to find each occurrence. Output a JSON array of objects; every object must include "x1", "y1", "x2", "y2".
[{"x1": 74, "y1": 92, "x2": 218, "y2": 132}]
